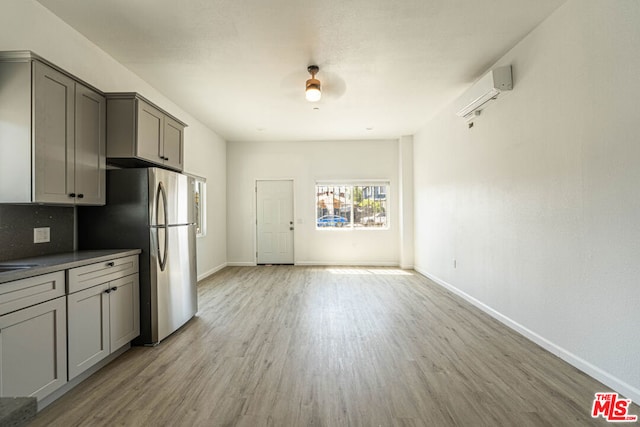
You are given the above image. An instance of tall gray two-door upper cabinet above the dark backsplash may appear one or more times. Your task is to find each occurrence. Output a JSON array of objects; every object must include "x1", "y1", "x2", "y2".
[{"x1": 0, "y1": 52, "x2": 106, "y2": 205}]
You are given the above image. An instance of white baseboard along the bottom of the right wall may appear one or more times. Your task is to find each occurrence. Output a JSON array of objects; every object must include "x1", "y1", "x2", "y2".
[{"x1": 414, "y1": 267, "x2": 640, "y2": 403}]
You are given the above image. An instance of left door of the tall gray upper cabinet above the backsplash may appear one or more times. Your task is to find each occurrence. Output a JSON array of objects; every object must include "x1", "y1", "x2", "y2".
[{"x1": 32, "y1": 61, "x2": 75, "y2": 204}]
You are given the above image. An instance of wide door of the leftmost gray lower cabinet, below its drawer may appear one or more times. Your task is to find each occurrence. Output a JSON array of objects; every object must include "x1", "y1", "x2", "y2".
[{"x1": 0, "y1": 297, "x2": 67, "y2": 400}]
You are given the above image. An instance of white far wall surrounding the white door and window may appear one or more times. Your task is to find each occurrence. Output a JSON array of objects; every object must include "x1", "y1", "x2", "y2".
[{"x1": 227, "y1": 140, "x2": 399, "y2": 265}]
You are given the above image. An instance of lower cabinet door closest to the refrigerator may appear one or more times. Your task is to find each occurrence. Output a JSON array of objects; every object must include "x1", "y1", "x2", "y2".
[{"x1": 109, "y1": 274, "x2": 140, "y2": 352}]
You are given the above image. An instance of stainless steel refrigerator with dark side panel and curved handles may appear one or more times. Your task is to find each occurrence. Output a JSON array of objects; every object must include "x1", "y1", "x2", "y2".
[{"x1": 78, "y1": 168, "x2": 198, "y2": 345}]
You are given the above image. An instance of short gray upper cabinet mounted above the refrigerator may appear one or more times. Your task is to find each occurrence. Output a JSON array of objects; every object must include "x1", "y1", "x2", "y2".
[{"x1": 107, "y1": 93, "x2": 186, "y2": 171}]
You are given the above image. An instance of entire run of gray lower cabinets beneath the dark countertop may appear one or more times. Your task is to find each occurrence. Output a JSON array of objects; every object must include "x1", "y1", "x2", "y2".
[{"x1": 0, "y1": 255, "x2": 140, "y2": 404}]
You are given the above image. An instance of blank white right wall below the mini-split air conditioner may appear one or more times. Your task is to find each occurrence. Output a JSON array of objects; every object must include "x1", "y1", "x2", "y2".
[{"x1": 414, "y1": 0, "x2": 640, "y2": 401}]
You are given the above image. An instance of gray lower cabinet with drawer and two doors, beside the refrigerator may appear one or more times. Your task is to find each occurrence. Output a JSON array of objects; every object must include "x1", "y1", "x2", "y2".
[{"x1": 67, "y1": 256, "x2": 140, "y2": 380}]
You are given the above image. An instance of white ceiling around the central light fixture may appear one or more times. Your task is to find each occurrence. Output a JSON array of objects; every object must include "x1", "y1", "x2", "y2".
[{"x1": 38, "y1": 0, "x2": 565, "y2": 141}]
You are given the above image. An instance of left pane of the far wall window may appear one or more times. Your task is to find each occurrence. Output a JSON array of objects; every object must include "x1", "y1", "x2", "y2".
[{"x1": 316, "y1": 185, "x2": 352, "y2": 228}]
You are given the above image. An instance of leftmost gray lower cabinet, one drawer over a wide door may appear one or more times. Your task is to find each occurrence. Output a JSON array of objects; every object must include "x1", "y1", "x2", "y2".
[{"x1": 0, "y1": 272, "x2": 67, "y2": 400}]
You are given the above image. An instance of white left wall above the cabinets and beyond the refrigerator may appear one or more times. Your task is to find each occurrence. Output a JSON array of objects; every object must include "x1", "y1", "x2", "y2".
[{"x1": 0, "y1": 0, "x2": 226, "y2": 277}]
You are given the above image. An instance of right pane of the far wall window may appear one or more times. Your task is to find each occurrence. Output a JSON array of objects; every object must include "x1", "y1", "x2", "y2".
[{"x1": 353, "y1": 185, "x2": 388, "y2": 228}]
